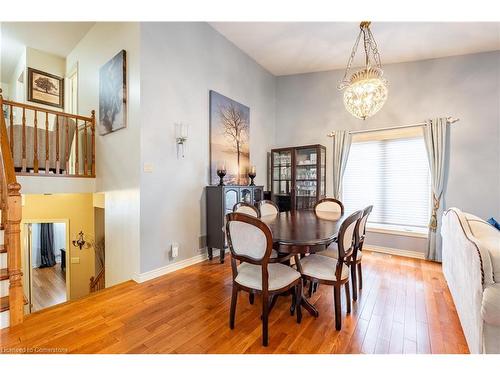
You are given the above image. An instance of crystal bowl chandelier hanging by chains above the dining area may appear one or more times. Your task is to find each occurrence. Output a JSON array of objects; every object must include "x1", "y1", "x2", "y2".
[{"x1": 338, "y1": 21, "x2": 388, "y2": 120}]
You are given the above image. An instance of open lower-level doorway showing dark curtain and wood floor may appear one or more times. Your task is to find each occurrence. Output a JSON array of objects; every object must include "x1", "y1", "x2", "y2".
[{"x1": 25, "y1": 221, "x2": 69, "y2": 313}]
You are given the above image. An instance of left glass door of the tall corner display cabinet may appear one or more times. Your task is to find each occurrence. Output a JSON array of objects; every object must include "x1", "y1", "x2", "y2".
[{"x1": 271, "y1": 150, "x2": 292, "y2": 211}]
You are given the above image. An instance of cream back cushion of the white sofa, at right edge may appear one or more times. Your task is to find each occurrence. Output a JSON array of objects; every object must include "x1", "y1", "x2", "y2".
[{"x1": 466, "y1": 214, "x2": 500, "y2": 282}]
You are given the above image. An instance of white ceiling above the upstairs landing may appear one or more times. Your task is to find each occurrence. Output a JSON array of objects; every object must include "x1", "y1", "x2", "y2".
[{"x1": 0, "y1": 22, "x2": 94, "y2": 81}]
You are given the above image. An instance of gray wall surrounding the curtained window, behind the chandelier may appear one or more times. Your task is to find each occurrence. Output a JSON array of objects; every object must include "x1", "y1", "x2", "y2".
[{"x1": 275, "y1": 51, "x2": 500, "y2": 251}]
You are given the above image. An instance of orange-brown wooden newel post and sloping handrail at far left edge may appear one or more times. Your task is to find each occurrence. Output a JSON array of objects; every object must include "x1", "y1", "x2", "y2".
[{"x1": 0, "y1": 89, "x2": 24, "y2": 326}]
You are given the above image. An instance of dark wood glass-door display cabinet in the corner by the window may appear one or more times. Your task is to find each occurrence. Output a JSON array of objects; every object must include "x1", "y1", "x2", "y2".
[{"x1": 271, "y1": 145, "x2": 326, "y2": 211}]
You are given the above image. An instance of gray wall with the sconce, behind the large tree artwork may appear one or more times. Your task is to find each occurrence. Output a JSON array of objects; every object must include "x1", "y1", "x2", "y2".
[{"x1": 140, "y1": 23, "x2": 275, "y2": 272}]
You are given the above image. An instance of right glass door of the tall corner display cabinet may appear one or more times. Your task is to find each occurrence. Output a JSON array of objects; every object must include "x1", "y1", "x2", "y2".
[{"x1": 295, "y1": 147, "x2": 318, "y2": 210}]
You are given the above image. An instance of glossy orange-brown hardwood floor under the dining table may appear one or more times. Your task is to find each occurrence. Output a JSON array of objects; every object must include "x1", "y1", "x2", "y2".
[{"x1": 0, "y1": 251, "x2": 468, "y2": 353}]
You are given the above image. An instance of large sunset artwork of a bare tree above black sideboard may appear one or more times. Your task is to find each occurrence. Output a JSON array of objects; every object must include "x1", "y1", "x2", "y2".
[{"x1": 209, "y1": 90, "x2": 250, "y2": 185}]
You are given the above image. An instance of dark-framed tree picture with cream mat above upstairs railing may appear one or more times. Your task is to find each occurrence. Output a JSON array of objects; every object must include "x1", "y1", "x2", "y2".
[{"x1": 28, "y1": 67, "x2": 64, "y2": 108}]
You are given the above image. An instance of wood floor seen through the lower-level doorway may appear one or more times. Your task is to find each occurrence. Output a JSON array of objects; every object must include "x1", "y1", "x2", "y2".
[{"x1": 31, "y1": 263, "x2": 66, "y2": 312}]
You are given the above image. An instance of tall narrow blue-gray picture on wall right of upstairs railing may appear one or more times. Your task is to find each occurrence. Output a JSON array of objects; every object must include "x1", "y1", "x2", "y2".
[{"x1": 99, "y1": 50, "x2": 127, "y2": 135}]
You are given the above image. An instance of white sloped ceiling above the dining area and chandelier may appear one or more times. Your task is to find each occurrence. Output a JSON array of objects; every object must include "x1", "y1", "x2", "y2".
[{"x1": 210, "y1": 22, "x2": 500, "y2": 75}]
